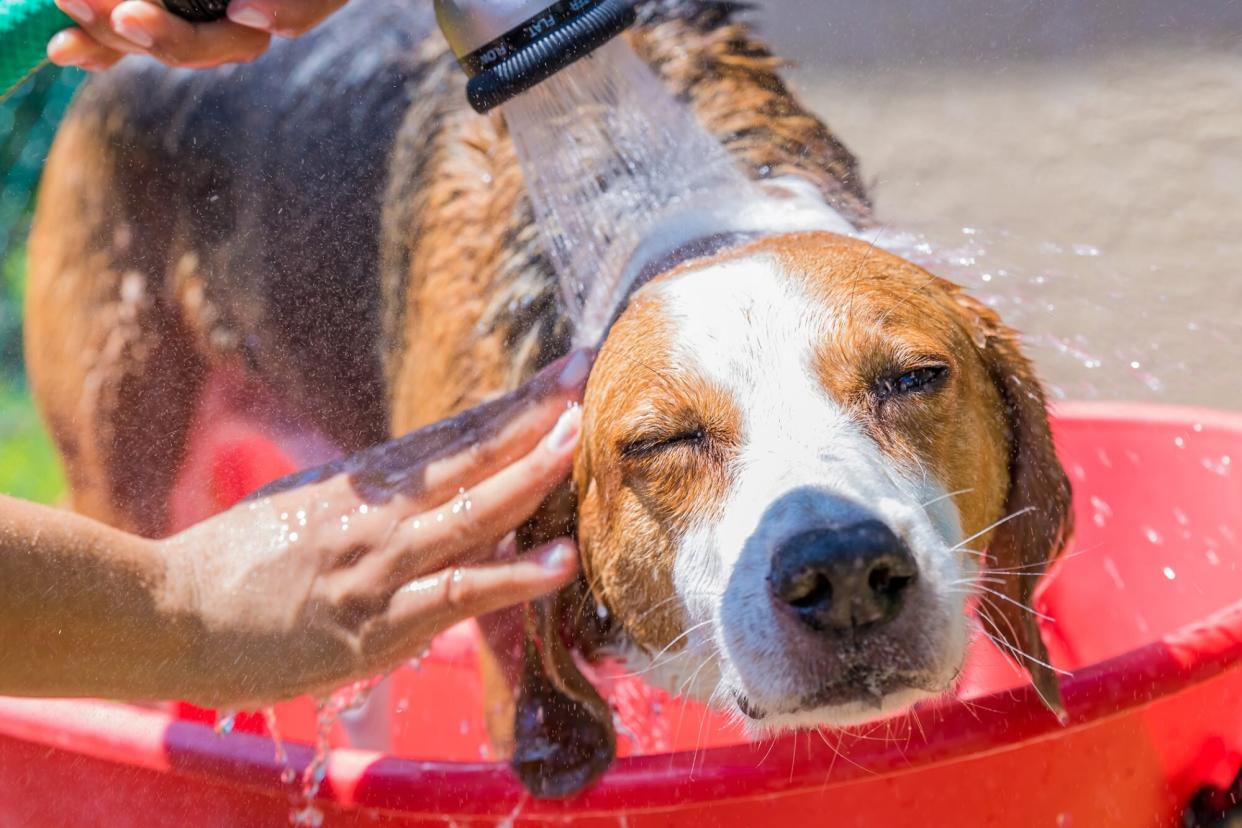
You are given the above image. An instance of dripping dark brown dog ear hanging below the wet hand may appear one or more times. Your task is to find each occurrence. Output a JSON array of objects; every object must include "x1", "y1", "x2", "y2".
[{"x1": 510, "y1": 488, "x2": 616, "y2": 798}]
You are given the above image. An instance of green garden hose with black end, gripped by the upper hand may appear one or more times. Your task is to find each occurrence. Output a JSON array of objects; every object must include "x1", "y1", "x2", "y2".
[{"x1": 0, "y1": 0, "x2": 229, "y2": 101}]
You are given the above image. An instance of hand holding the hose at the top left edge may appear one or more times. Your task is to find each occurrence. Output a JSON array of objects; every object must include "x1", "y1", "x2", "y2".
[{"x1": 47, "y1": 0, "x2": 345, "y2": 71}]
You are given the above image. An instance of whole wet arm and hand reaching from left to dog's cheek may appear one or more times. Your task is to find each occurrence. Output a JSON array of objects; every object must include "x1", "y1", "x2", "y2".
[{"x1": 0, "y1": 354, "x2": 590, "y2": 706}]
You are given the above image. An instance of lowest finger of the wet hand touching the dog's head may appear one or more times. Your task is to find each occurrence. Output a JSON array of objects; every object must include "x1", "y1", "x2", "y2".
[{"x1": 368, "y1": 539, "x2": 578, "y2": 652}]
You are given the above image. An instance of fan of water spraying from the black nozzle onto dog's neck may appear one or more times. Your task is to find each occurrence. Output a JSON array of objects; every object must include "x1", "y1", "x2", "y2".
[{"x1": 503, "y1": 38, "x2": 760, "y2": 344}]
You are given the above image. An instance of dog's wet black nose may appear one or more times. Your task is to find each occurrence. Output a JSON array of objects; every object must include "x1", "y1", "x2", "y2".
[{"x1": 768, "y1": 520, "x2": 919, "y2": 631}]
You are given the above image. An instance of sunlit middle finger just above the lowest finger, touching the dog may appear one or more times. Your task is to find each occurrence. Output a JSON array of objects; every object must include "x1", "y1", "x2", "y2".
[{"x1": 379, "y1": 408, "x2": 582, "y2": 588}]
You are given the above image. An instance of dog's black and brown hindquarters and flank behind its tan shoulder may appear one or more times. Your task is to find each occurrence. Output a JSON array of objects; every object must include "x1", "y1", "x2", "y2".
[{"x1": 27, "y1": 0, "x2": 459, "y2": 534}]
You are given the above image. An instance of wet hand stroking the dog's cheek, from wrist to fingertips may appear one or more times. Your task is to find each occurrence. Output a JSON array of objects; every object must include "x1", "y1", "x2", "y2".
[{"x1": 163, "y1": 353, "x2": 590, "y2": 706}]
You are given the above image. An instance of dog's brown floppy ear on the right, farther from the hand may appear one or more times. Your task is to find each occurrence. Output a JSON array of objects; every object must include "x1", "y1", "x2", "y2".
[{"x1": 956, "y1": 293, "x2": 1073, "y2": 718}]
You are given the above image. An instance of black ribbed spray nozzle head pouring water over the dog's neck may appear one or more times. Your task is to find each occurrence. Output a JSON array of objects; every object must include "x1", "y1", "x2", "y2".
[{"x1": 461, "y1": 0, "x2": 637, "y2": 113}]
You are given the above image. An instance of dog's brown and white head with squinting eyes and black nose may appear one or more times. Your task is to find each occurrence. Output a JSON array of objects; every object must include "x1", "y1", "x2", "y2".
[{"x1": 511, "y1": 233, "x2": 1069, "y2": 794}]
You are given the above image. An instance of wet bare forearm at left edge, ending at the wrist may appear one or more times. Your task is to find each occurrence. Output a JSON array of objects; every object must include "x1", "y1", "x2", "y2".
[{"x1": 0, "y1": 497, "x2": 205, "y2": 699}]
